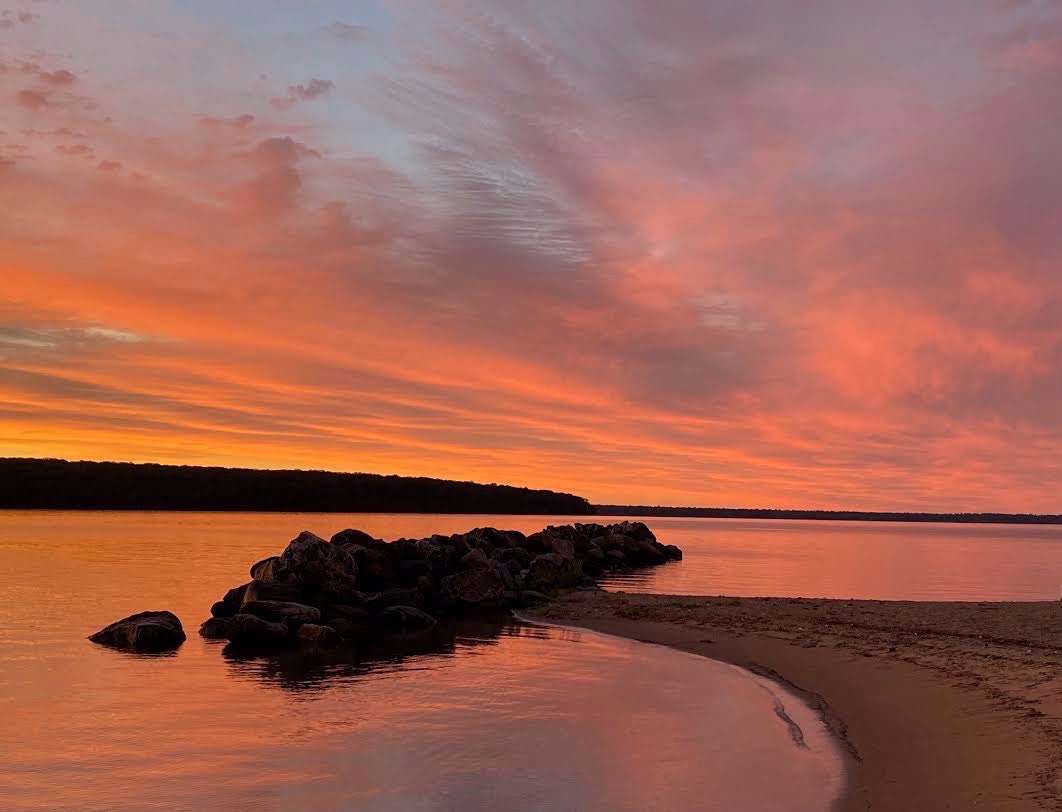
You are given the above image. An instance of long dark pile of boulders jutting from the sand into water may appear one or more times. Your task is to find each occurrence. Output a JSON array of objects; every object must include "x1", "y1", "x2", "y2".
[{"x1": 200, "y1": 521, "x2": 682, "y2": 649}]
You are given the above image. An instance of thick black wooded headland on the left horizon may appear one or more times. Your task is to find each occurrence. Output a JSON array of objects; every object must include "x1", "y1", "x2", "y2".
[{"x1": 0, "y1": 457, "x2": 592, "y2": 516}]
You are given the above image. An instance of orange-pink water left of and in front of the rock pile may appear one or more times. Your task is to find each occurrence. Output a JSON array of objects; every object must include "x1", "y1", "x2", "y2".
[{"x1": 0, "y1": 512, "x2": 841, "y2": 812}]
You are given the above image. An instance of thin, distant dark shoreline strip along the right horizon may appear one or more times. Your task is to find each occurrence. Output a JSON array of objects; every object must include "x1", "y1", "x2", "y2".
[{"x1": 594, "y1": 504, "x2": 1062, "y2": 524}]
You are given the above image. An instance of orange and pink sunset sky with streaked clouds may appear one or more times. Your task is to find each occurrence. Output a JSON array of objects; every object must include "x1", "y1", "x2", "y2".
[{"x1": 0, "y1": 0, "x2": 1062, "y2": 513}]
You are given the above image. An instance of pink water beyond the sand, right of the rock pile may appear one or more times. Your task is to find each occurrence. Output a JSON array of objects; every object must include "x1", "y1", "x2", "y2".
[{"x1": 602, "y1": 518, "x2": 1062, "y2": 601}]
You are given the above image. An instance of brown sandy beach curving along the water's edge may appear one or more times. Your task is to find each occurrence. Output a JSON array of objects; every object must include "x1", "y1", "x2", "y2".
[{"x1": 531, "y1": 591, "x2": 1062, "y2": 812}]
